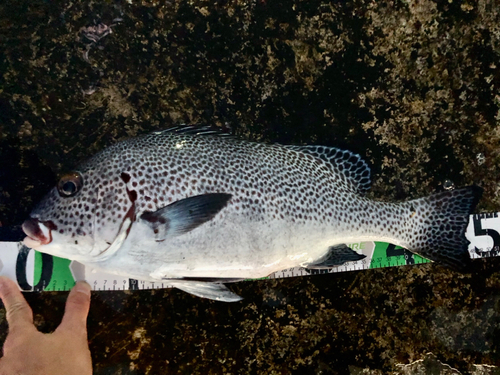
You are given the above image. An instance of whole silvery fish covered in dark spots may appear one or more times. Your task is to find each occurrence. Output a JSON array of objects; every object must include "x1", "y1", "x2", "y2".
[{"x1": 22, "y1": 126, "x2": 482, "y2": 302}]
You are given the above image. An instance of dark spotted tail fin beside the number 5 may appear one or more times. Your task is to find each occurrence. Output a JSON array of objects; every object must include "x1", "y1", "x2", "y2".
[{"x1": 404, "y1": 186, "x2": 483, "y2": 270}]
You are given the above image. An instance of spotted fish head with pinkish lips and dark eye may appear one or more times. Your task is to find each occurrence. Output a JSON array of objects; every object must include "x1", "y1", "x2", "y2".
[{"x1": 22, "y1": 166, "x2": 134, "y2": 261}]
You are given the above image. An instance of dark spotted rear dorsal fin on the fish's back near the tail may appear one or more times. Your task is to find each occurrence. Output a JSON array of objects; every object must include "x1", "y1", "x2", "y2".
[{"x1": 285, "y1": 146, "x2": 371, "y2": 194}]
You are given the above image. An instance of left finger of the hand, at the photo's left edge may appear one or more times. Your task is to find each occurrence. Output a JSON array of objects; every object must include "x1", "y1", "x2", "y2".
[{"x1": 0, "y1": 276, "x2": 33, "y2": 330}]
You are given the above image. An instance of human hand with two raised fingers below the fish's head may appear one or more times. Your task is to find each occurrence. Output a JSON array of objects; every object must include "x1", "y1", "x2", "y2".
[{"x1": 0, "y1": 276, "x2": 92, "y2": 375}]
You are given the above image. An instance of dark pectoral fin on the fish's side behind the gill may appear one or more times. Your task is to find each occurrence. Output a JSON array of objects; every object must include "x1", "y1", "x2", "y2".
[{"x1": 140, "y1": 193, "x2": 232, "y2": 241}]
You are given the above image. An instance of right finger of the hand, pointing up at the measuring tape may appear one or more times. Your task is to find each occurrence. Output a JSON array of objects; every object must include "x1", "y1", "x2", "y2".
[{"x1": 57, "y1": 281, "x2": 90, "y2": 332}]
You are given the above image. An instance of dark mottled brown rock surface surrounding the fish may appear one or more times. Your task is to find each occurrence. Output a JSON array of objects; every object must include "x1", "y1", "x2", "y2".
[{"x1": 0, "y1": 0, "x2": 500, "y2": 374}]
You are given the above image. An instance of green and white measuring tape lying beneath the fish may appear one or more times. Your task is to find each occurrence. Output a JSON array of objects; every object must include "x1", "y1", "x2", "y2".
[{"x1": 0, "y1": 213, "x2": 500, "y2": 291}]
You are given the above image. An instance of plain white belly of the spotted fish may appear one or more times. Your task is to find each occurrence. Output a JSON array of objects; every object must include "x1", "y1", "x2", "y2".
[{"x1": 84, "y1": 216, "x2": 338, "y2": 281}]
